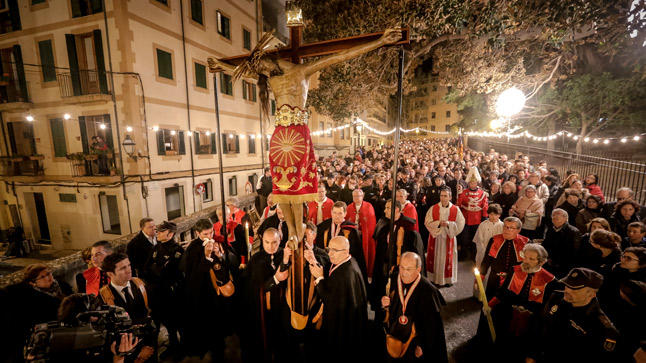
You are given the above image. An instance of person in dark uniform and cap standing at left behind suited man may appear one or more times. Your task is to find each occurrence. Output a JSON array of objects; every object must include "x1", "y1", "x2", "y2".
[{"x1": 142, "y1": 221, "x2": 184, "y2": 358}]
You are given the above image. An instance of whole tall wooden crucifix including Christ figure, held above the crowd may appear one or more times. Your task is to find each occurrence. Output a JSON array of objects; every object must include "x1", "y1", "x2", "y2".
[{"x1": 208, "y1": 2, "x2": 409, "y2": 329}]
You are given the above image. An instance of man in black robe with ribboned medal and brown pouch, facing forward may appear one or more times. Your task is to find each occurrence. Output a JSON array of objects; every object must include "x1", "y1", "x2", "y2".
[{"x1": 381, "y1": 252, "x2": 448, "y2": 362}]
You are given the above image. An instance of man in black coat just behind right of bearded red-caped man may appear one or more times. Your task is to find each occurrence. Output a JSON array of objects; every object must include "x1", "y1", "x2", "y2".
[{"x1": 543, "y1": 208, "x2": 581, "y2": 278}]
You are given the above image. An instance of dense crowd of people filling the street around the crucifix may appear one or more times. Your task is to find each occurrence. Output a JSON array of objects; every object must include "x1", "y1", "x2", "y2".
[{"x1": 2, "y1": 139, "x2": 646, "y2": 362}]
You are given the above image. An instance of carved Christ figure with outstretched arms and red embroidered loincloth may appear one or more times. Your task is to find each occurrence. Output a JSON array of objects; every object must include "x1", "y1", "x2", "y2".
[{"x1": 208, "y1": 29, "x2": 402, "y2": 247}]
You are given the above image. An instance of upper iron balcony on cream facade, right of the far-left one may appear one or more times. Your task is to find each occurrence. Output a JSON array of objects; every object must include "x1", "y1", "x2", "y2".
[{"x1": 56, "y1": 70, "x2": 111, "y2": 104}]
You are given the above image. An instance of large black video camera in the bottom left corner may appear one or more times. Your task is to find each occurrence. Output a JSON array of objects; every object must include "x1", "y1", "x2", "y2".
[{"x1": 25, "y1": 305, "x2": 155, "y2": 362}]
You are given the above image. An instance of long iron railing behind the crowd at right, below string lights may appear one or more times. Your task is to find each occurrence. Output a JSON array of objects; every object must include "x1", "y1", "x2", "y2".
[{"x1": 468, "y1": 138, "x2": 646, "y2": 204}]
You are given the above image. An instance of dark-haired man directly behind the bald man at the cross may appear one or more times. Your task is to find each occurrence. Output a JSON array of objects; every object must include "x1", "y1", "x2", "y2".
[{"x1": 316, "y1": 201, "x2": 368, "y2": 285}]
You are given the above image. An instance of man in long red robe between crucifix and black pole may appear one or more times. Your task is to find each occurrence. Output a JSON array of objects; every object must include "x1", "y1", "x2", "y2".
[{"x1": 345, "y1": 188, "x2": 377, "y2": 277}]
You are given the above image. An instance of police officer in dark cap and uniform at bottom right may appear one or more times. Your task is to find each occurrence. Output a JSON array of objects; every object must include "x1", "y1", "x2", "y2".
[{"x1": 527, "y1": 267, "x2": 619, "y2": 362}]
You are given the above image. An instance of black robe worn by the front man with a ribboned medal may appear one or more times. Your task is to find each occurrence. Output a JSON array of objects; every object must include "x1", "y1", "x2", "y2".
[{"x1": 388, "y1": 278, "x2": 448, "y2": 362}]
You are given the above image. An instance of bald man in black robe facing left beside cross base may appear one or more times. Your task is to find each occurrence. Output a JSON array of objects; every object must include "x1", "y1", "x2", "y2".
[{"x1": 310, "y1": 236, "x2": 368, "y2": 361}]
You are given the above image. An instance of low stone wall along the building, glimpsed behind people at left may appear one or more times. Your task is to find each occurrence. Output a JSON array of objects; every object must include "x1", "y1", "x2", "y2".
[{"x1": 0, "y1": 194, "x2": 255, "y2": 288}]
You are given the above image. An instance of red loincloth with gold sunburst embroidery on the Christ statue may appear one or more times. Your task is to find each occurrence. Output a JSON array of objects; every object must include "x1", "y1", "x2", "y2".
[{"x1": 269, "y1": 105, "x2": 318, "y2": 203}]
